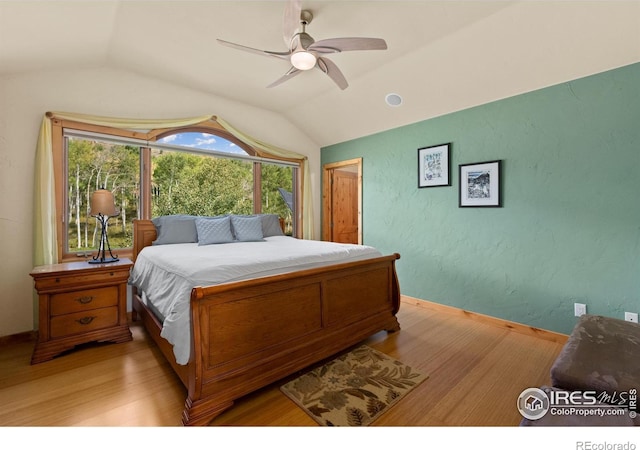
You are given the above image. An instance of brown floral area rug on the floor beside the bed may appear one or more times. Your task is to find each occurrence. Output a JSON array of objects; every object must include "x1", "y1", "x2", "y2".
[{"x1": 280, "y1": 345, "x2": 428, "y2": 426}]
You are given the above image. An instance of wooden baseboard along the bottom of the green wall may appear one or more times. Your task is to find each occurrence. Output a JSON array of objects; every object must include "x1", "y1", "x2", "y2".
[{"x1": 400, "y1": 295, "x2": 569, "y2": 344}]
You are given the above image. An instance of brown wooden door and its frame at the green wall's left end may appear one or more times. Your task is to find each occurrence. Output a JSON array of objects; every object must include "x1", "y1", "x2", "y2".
[{"x1": 322, "y1": 158, "x2": 362, "y2": 244}]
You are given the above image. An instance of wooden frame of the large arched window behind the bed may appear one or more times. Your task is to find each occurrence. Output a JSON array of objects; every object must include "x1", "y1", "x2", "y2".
[{"x1": 51, "y1": 118, "x2": 302, "y2": 262}]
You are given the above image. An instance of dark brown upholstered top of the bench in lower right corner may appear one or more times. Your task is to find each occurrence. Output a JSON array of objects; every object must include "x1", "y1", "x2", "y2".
[{"x1": 551, "y1": 314, "x2": 640, "y2": 395}]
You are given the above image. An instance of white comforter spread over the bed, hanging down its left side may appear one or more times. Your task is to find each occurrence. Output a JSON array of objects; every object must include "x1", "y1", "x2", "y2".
[{"x1": 129, "y1": 236, "x2": 382, "y2": 364}]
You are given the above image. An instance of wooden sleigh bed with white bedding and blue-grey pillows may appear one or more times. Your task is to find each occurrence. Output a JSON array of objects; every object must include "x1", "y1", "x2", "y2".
[{"x1": 129, "y1": 214, "x2": 400, "y2": 425}]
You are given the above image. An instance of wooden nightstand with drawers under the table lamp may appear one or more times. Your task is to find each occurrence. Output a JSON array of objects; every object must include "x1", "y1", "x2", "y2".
[{"x1": 30, "y1": 258, "x2": 133, "y2": 364}]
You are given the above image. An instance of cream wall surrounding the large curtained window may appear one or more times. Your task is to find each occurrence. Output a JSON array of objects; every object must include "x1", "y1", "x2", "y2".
[{"x1": 0, "y1": 68, "x2": 320, "y2": 336}]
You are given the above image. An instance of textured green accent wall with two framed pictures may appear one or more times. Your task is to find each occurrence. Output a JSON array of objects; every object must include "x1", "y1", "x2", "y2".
[{"x1": 321, "y1": 63, "x2": 640, "y2": 333}]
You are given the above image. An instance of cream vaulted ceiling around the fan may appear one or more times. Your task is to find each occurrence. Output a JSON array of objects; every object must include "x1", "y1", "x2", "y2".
[{"x1": 0, "y1": 0, "x2": 640, "y2": 146}]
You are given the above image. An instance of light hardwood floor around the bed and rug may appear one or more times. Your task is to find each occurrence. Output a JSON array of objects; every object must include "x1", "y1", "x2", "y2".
[{"x1": 0, "y1": 299, "x2": 563, "y2": 427}]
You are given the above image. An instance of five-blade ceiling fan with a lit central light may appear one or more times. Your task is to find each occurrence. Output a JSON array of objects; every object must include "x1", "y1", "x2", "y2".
[{"x1": 217, "y1": 0, "x2": 387, "y2": 90}]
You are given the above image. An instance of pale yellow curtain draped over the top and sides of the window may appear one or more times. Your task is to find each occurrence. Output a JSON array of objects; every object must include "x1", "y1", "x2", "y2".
[{"x1": 34, "y1": 112, "x2": 313, "y2": 265}]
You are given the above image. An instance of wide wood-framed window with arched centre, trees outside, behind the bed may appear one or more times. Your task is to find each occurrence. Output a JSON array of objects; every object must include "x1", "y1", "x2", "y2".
[{"x1": 54, "y1": 121, "x2": 299, "y2": 260}]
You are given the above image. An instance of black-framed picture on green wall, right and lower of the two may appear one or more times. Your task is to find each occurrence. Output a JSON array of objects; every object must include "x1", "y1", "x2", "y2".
[{"x1": 459, "y1": 160, "x2": 502, "y2": 208}]
